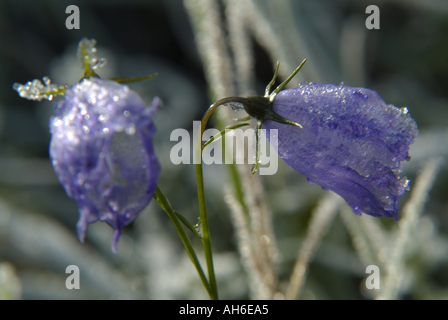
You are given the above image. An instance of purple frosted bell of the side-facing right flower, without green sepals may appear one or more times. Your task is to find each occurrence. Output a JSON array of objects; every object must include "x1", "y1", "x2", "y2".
[{"x1": 263, "y1": 83, "x2": 418, "y2": 220}]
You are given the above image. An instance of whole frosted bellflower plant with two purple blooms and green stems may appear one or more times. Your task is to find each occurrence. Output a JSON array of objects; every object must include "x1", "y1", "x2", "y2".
[{"x1": 14, "y1": 35, "x2": 424, "y2": 299}]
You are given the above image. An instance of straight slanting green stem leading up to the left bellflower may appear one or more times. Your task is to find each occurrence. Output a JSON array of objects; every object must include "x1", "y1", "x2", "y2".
[{"x1": 154, "y1": 187, "x2": 215, "y2": 299}]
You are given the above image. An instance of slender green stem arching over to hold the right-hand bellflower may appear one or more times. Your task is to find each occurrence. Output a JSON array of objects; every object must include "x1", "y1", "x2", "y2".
[{"x1": 195, "y1": 97, "x2": 246, "y2": 300}]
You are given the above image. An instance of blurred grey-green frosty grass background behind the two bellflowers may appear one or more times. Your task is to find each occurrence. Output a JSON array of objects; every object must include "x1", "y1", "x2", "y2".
[{"x1": 0, "y1": 0, "x2": 448, "y2": 299}]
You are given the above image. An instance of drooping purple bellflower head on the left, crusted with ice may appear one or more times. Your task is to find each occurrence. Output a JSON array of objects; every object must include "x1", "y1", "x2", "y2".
[{"x1": 50, "y1": 77, "x2": 161, "y2": 251}]
